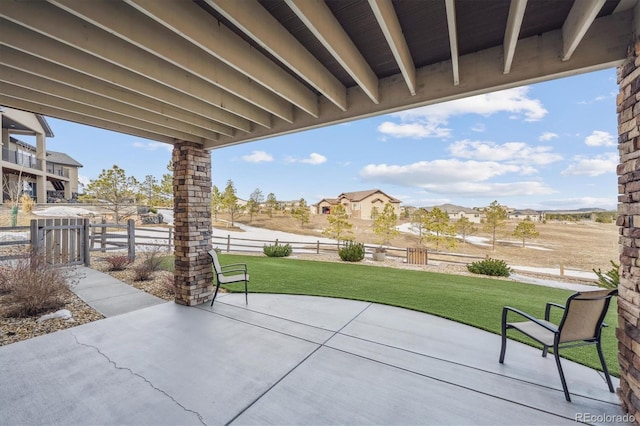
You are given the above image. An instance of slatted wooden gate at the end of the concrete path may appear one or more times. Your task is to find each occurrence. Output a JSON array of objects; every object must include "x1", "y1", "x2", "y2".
[{"x1": 31, "y1": 219, "x2": 89, "y2": 266}]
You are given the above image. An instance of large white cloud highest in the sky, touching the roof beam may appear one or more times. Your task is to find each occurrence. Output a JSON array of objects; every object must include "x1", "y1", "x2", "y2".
[{"x1": 378, "y1": 87, "x2": 547, "y2": 138}]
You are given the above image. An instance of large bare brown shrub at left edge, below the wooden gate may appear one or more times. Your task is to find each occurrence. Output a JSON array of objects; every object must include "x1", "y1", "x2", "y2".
[{"x1": 0, "y1": 251, "x2": 73, "y2": 317}]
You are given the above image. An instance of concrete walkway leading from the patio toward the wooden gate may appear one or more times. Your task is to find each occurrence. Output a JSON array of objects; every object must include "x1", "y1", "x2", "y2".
[{"x1": 71, "y1": 266, "x2": 167, "y2": 318}]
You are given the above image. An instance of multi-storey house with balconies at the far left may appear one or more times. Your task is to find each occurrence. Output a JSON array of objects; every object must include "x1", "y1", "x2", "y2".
[{"x1": 0, "y1": 107, "x2": 82, "y2": 204}]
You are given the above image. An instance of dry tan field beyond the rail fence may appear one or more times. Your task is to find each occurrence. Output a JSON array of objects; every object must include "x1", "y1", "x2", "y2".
[{"x1": 232, "y1": 214, "x2": 619, "y2": 271}]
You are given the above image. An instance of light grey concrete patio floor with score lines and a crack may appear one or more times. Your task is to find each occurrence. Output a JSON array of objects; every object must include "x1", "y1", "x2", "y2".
[{"x1": 0, "y1": 294, "x2": 623, "y2": 425}]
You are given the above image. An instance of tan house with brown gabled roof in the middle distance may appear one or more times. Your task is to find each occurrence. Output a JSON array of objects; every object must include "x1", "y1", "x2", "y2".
[{"x1": 314, "y1": 189, "x2": 400, "y2": 220}]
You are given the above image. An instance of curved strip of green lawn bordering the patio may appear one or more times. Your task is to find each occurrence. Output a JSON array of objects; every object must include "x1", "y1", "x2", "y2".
[{"x1": 178, "y1": 254, "x2": 619, "y2": 376}]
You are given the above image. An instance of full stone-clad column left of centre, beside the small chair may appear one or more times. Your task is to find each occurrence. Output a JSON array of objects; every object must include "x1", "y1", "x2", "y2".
[{"x1": 173, "y1": 141, "x2": 213, "y2": 306}]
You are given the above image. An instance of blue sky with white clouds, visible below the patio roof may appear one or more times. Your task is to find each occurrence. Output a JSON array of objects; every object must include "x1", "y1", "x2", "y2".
[{"x1": 41, "y1": 68, "x2": 618, "y2": 209}]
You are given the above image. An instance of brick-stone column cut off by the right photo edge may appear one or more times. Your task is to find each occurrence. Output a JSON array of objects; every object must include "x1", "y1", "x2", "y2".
[{"x1": 616, "y1": 41, "x2": 640, "y2": 423}]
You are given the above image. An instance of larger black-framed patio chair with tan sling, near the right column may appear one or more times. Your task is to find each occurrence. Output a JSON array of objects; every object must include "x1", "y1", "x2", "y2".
[{"x1": 500, "y1": 290, "x2": 618, "y2": 401}]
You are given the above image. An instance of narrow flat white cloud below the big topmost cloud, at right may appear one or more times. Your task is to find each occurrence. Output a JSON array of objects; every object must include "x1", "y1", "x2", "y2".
[{"x1": 449, "y1": 139, "x2": 562, "y2": 166}]
